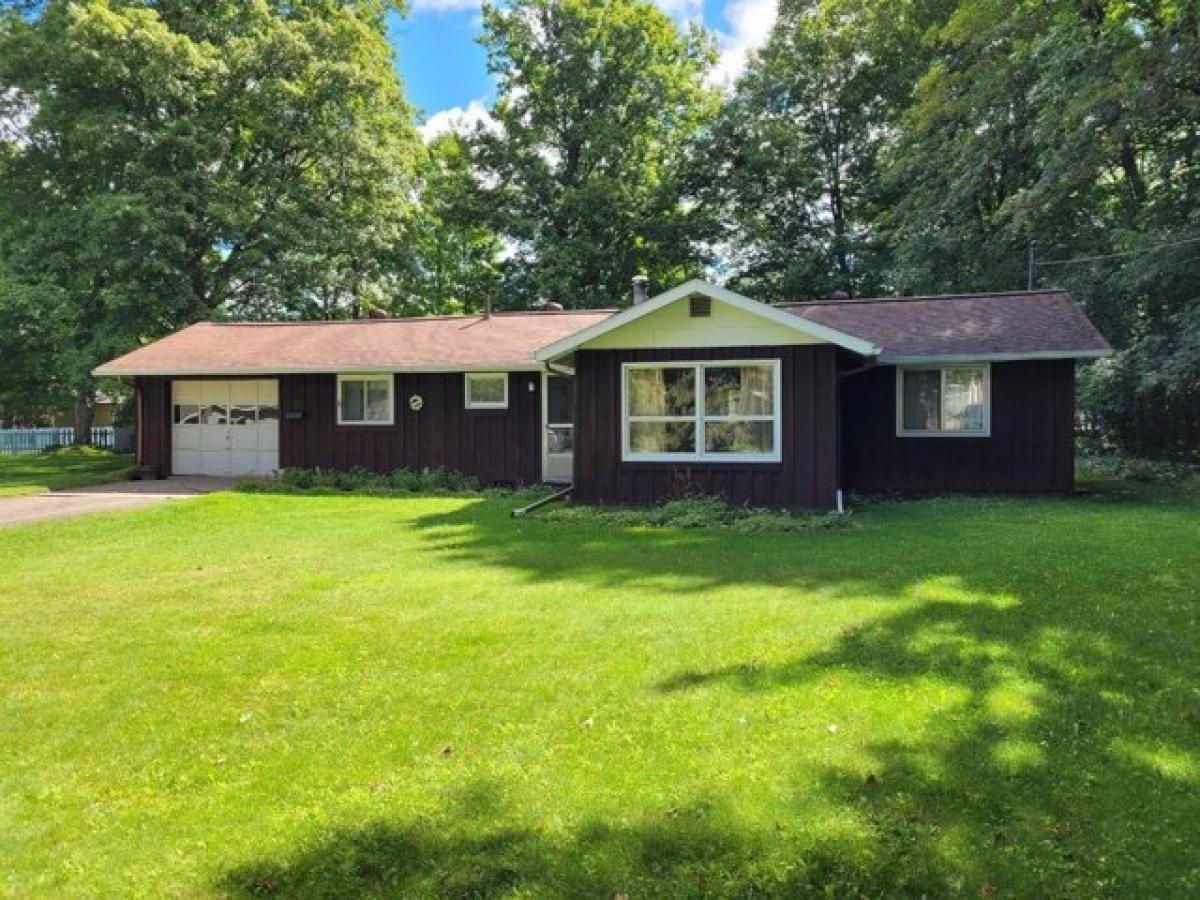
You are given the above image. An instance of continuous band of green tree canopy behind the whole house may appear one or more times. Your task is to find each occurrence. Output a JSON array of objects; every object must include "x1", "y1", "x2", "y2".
[{"x1": 0, "y1": 0, "x2": 1200, "y2": 452}]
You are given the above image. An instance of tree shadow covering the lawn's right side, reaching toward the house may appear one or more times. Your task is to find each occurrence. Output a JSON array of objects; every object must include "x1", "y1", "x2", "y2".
[{"x1": 400, "y1": 497, "x2": 1200, "y2": 896}]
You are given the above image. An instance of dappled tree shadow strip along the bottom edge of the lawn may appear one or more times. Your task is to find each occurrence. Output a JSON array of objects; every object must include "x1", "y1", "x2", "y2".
[{"x1": 216, "y1": 804, "x2": 949, "y2": 900}]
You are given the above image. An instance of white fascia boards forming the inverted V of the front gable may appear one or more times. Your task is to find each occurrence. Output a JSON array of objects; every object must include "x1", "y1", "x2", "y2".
[{"x1": 534, "y1": 278, "x2": 880, "y2": 362}]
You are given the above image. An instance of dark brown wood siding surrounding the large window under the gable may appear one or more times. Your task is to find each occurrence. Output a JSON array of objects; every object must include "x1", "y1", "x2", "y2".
[{"x1": 575, "y1": 346, "x2": 838, "y2": 509}]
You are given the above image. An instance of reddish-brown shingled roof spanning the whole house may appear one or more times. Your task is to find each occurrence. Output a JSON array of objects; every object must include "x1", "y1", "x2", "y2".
[{"x1": 95, "y1": 280, "x2": 1111, "y2": 377}]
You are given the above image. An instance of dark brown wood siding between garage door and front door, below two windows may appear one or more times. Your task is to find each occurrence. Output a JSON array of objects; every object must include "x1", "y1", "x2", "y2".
[{"x1": 280, "y1": 372, "x2": 541, "y2": 485}]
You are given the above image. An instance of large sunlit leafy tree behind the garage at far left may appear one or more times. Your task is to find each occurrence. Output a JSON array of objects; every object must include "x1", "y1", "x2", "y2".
[{"x1": 0, "y1": 0, "x2": 419, "y2": 438}]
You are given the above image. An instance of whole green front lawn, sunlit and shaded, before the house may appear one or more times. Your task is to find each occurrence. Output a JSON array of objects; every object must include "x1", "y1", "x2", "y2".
[{"x1": 0, "y1": 488, "x2": 1200, "y2": 900}]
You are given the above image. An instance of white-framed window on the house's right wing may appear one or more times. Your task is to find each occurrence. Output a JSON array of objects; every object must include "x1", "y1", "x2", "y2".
[{"x1": 896, "y1": 365, "x2": 991, "y2": 438}]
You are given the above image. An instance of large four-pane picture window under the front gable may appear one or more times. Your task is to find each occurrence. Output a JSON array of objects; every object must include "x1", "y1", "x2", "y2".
[{"x1": 622, "y1": 360, "x2": 781, "y2": 462}]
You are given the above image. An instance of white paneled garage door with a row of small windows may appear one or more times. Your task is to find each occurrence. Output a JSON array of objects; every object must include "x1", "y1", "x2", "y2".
[{"x1": 170, "y1": 380, "x2": 280, "y2": 475}]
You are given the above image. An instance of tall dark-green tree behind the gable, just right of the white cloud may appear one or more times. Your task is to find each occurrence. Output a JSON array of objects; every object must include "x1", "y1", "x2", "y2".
[{"x1": 707, "y1": 0, "x2": 947, "y2": 300}]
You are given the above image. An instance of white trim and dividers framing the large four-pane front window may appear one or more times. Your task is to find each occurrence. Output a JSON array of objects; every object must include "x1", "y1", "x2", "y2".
[{"x1": 620, "y1": 359, "x2": 784, "y2": 463}]
